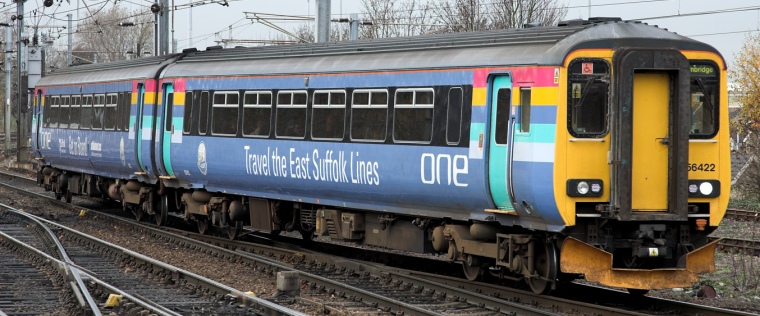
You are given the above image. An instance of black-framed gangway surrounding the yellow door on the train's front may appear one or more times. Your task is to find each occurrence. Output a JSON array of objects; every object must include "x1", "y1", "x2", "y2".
[{"x1": 609, "y1": 48, "x2": 691, "y2": 221}]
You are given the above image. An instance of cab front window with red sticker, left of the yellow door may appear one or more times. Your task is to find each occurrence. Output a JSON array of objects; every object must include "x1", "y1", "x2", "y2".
[{"x1": 567, "y1": 59, "x2": 610, "y2": 137}]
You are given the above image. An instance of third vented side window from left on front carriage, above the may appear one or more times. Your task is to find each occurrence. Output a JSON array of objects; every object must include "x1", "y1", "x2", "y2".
[{"x1": 275, "y1": 91, "x2": 307, "y2": 138}]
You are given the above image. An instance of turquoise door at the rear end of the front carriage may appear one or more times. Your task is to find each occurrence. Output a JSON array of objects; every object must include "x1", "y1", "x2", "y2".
[{"x1": 156, "y1": 83, "x2": 175, "y2": 177}]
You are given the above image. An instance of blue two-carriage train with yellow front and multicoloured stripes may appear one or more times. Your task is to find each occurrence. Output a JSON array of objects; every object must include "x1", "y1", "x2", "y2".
[{"x1": 32, "y1": 18, "x2": 731, "y2": 293}]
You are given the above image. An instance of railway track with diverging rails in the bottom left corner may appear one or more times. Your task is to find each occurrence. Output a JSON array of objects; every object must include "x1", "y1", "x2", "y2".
[{"x1": 0, "y1": 198, "x2": 299, "y2": 315}]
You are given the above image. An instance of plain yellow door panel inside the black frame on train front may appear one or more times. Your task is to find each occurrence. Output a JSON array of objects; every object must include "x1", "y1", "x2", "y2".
[{"x1": 631, "y1": 72, "x2": 670, "y2": 211}]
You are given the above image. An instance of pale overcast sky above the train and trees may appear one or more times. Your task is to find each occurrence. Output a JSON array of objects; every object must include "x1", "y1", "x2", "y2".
[{"x1": 16, "y1": 0, "x2": 760, "y2": 67}]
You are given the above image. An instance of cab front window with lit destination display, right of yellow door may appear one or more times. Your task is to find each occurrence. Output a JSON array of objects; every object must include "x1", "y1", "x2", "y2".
[{"x1": 689, "y1": 62, "x2": 720, "y2": 138}]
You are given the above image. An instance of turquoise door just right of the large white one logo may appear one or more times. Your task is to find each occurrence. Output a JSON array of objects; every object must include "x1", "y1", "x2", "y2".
[{"x1": 488, "y1": 75, "x2": 514, "y2": 210}]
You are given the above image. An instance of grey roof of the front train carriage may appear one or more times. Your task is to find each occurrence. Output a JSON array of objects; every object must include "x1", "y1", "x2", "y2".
[{"x1": 165, "y1": 20, "x2": 720, "y2": 77}]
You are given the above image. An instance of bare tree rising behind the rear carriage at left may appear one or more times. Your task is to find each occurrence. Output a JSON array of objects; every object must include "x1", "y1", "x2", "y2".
[{"x1": 74, "y1": 5, "x2": 153, "y2": 62}]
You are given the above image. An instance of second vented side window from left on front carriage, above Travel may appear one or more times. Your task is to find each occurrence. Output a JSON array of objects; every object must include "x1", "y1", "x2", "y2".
[{"x1": 243, "y1": 92, "x2": 272, "y2": 137}]
